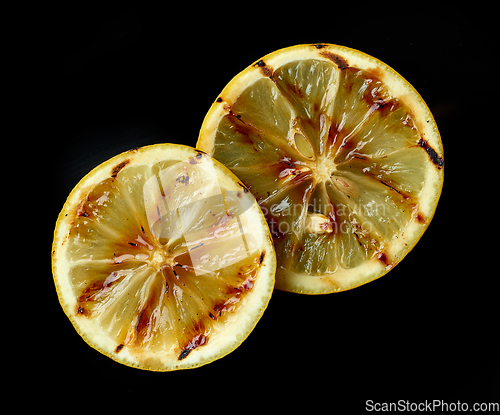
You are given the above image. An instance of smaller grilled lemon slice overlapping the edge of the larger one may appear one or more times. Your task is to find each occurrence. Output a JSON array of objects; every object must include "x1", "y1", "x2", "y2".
[{"x1": 52, "y1": 144, "x2": 276, "y2": 371}]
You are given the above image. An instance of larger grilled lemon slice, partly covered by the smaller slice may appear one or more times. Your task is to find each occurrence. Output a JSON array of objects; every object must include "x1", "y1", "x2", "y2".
[{"x1": 197, "y1": 44, "x2": 444, "y2": 294}]
